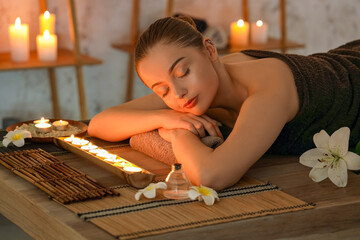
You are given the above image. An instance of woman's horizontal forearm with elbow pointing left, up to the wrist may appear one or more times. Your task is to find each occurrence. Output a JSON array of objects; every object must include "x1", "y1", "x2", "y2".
[{"x1": 88, "y1": 107, "x2": 163, "y2": 141}]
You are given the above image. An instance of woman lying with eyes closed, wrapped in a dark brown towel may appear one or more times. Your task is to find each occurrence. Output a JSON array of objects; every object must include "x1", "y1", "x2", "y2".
[{"x1": 88, "y1": 17, "x2": 360, "y2": 189}]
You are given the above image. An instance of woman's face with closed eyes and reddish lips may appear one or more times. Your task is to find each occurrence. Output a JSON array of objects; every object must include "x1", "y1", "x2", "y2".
[{"x1": 137, "y1": 43, "x2": 219, "y2": 115}]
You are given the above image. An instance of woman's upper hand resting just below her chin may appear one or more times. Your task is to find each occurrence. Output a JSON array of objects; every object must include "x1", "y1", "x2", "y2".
[{"x1": 157, "y1": 110, "x2": 224, "y2": 139}]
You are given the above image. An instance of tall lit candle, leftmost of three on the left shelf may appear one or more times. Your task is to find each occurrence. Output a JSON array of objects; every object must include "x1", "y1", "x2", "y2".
[{"x1": 9, "y1": 17, "x2": 30, "y2": 62}]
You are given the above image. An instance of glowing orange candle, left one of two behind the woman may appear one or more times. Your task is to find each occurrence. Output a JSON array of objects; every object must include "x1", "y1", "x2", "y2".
[{"x1": 230, "y1": 19, "x2": 249, "y2": 47}]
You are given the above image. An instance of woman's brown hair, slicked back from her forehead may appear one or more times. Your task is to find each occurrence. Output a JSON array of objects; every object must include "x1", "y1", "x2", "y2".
[{"x1": 135, "y1": 16, "x2": 204, "y2": 66}]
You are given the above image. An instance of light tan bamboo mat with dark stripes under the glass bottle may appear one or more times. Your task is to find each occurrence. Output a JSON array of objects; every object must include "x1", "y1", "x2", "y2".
[{"x1": 64, "y1": 177, "x2": 314, "y2": 239}]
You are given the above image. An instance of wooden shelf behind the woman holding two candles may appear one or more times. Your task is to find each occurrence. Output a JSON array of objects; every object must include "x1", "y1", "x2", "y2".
[{"x1": 218, "y1": 38, "x2": 305, "y2": 54}]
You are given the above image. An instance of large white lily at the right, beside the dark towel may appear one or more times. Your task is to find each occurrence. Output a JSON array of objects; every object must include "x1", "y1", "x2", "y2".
[{"x1": 300, "y1": 127, "x2": 360, "y2": 187}]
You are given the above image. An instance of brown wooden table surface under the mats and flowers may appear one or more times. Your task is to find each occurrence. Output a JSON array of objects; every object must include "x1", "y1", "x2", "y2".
[{"x1": 0, "y1": 142, "x2": 360, "y2": 240}]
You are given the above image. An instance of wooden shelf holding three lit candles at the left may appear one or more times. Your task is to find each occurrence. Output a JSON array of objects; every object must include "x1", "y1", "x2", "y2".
[{"x1": 0, "y1": 49, "x2": 102, "y2": 71}]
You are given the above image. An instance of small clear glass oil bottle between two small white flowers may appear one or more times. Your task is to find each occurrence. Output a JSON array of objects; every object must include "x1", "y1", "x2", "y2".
[{"x1": 163, "y1": 163, "x2": 190, "y2": 199}]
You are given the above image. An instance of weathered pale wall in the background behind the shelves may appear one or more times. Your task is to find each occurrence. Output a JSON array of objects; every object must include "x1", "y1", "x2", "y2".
[{"x1": 0, "y1": 0, "x2": 360, "y2": 124}]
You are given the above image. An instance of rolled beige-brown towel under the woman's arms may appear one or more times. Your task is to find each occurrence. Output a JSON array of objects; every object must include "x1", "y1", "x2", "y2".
[{"x1": 130, "y1": 130, "x2": 223, "y2": 165}]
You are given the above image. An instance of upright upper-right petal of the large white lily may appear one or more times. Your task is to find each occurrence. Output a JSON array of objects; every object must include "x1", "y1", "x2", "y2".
[{"x1": 329, "y1": 127, "x2": 350, "y2": 157}]
